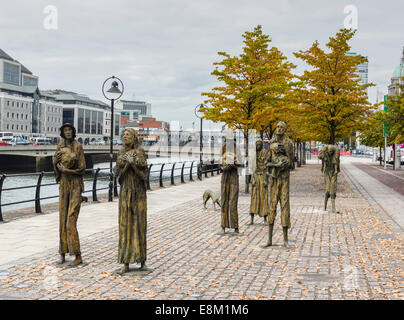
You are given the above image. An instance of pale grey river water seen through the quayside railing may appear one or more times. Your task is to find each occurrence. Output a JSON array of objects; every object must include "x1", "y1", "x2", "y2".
[{"x1": 1, "y1": 157, "x2": 197, "y2": 212}]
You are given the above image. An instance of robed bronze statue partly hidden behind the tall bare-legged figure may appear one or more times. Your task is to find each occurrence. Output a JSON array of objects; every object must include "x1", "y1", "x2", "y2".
[{"x1": 250, "y1": 139, "x2": 268, "y2": 224}]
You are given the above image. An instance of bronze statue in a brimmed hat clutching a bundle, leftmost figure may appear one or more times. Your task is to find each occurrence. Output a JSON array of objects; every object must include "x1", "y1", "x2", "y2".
[{"x1": 53, "y1": 123, "x2": 86, "y2": 266}]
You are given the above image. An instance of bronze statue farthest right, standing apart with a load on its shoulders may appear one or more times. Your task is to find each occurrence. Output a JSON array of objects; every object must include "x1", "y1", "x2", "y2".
[{"x1": 318, "y1": 145, "x2": 340, "y2": 213}]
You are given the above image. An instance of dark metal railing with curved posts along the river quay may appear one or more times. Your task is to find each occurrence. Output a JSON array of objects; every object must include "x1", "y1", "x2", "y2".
[{"x1": 0, "y1": 161, "x2": 221, "y2": 222}]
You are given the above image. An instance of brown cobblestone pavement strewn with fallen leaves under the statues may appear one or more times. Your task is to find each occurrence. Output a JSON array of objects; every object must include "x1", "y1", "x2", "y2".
[{"x1": 0, "y1": 161, "x2": 404, "y2": 299}]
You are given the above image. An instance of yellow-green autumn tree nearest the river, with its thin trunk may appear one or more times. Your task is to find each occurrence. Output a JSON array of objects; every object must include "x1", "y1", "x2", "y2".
[{"x1": 202, "y1": 25, "x2": 295, "y2": 192}]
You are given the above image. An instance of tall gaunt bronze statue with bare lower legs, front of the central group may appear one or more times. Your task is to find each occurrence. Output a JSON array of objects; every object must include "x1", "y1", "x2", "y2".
[{"x1": 266, "y1": 121, "x2": 293, "y2": 248}]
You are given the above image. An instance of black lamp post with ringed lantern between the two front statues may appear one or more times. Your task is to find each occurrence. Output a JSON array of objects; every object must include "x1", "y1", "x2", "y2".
[{"x1": 102, "y1": 76, "x2": 124, "y2": 201}]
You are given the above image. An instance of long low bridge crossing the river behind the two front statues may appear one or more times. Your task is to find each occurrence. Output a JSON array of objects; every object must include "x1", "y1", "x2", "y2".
[{"x1": 0, "y1": 145, "x2": 220, "y2": 172}]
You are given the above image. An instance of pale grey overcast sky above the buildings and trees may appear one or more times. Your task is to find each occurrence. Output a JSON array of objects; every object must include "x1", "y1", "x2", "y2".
[{"x1": 0, "y1": 0, "x2": 404, "y2": 129}]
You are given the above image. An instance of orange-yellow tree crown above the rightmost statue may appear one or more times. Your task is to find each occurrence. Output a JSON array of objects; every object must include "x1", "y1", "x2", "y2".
[{"x1": 294, "y1": 29, "x2": 373, "y2": 144}]
